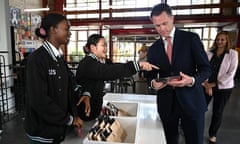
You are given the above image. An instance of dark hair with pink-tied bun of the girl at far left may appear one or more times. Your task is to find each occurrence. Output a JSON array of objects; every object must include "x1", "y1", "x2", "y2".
[{"x1": 35, "y1": 13, "x2": 67, "y2": 38}]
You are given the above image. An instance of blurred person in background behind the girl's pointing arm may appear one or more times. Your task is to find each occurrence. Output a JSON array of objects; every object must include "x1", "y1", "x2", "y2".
[{"x1": 138, "y1": 44, "x2": 148, "y2": 78}]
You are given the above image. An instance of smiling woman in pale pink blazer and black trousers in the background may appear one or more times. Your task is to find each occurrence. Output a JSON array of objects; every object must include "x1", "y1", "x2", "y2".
[{"x1": 204, "y1": 31, "x2": 238, "y2": 144}]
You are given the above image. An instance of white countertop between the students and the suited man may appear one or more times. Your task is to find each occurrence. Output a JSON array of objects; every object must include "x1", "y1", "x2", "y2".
[{"x1": 63, "y1": 93, "x2": 166, "y2": 144}]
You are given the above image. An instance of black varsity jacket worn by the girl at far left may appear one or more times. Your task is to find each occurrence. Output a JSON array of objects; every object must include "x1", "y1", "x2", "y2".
[{"x1": 24, "y1": 46, "x2": 73, "y2": 139}]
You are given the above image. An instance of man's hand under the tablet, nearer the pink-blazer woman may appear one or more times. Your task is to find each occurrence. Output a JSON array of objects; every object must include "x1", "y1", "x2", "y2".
[{"x1": 167, "y1": 72, "x2": 193, "y2": 87}]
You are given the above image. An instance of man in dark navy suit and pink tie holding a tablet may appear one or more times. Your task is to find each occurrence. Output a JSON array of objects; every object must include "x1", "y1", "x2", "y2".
[{"x1": 148, "y1": 3, "x2": 211, "y2": 144}]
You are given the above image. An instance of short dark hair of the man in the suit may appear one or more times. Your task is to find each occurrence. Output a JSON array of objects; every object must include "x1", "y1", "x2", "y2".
[{"x1": 151, "y1": 3, "x2": 172, "y2": 18}]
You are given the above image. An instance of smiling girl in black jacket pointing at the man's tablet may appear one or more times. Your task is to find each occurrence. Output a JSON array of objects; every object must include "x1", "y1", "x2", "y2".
[{"x1": 76, "y1": 34, "x2": 158, "y2": 121}]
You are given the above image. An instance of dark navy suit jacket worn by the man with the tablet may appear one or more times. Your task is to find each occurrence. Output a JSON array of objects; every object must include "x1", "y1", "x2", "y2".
[{"x1": 148, "y1": 29, "x2": 211, "y2": 117}]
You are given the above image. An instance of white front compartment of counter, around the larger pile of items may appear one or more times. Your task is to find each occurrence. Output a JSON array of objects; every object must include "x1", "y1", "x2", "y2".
[{"x1": 83, "y1": 117, "x2": 138, "y2": 144}]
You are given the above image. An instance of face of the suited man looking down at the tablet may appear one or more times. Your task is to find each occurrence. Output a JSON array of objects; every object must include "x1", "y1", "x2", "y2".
[{"x1": 152, "y1": 12, "x2": 174, "y2": 37}]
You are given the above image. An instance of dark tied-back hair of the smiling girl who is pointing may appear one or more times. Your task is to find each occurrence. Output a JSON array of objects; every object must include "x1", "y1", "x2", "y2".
[{"x1": 83, "y1": 34, "x2": 104, "y2": 54}]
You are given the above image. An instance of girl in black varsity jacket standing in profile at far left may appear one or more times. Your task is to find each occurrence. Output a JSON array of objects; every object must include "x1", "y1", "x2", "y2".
[{"x1": 24, "y1": 13, "x2": 90, "y2": 144}]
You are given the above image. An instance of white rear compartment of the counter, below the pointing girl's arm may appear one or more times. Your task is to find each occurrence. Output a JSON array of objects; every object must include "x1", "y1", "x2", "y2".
[{"x1": 103, "y1": 101, "x2": 139, "y2": 117}]
